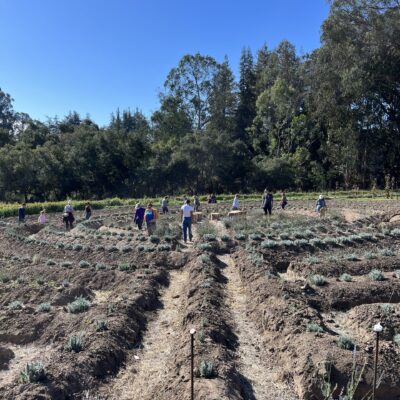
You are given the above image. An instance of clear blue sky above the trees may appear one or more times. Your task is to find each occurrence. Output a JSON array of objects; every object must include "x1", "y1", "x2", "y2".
[{"x1": 0, "y1": 0, "x2": 329, "y2": 125}]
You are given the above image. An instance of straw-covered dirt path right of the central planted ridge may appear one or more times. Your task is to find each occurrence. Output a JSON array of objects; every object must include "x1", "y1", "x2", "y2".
[{"x1": 219, "y1": 255, "x2": 297, "y2": 400}]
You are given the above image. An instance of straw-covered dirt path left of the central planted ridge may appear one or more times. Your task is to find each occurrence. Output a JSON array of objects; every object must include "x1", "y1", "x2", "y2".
[{"x1": 101, "y1": 269, "x2": 188, "y2": 400}]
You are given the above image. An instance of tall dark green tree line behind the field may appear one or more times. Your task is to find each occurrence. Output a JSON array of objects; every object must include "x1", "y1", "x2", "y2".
[{"x1": 0, "y1": 0, "x2": 400, "y2": 201}]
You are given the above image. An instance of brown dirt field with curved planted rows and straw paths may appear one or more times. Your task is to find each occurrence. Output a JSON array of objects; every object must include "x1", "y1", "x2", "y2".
[{"x1": 0, "y1": 199, "x2": 400, "y2": 400}]
